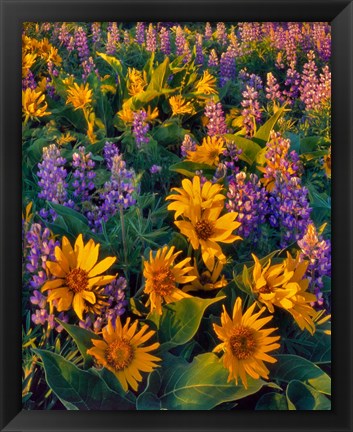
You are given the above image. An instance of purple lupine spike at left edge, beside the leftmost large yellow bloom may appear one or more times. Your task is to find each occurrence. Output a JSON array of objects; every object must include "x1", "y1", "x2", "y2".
[{"x1": 26, "y1": 223, "x2": 59, "y2": 290}]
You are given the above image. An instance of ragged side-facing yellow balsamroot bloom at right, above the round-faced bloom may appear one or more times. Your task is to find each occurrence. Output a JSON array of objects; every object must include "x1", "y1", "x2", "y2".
[{"x1": 252, "y1": 253, "x2": 316, "y2": 334}]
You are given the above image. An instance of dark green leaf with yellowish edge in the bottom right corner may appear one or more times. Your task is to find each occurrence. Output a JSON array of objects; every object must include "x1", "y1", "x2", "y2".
[{"x1": 286, "y1": 380, "x2": 331, "y2": 411}]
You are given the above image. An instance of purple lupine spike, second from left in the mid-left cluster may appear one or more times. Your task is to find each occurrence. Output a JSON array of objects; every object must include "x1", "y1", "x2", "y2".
[{"x1": 72, "y1": 146, "x2": 96, "y2": 201}]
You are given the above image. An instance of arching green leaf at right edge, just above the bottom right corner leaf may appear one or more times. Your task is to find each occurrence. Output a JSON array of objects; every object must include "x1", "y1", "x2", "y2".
[{"x1": 270, "y1": 354, "x2": 331, "y2": 395}]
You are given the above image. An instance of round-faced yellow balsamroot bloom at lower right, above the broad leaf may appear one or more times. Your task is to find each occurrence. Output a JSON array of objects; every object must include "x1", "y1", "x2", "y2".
[{"x1": 213, "y1": 297, "x2": 280, "y2": 388}]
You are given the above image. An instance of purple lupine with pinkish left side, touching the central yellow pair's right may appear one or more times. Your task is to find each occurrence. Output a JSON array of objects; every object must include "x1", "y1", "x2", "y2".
[{"x1": 226, "y1": 171, "x2": 268, "y2": 241}]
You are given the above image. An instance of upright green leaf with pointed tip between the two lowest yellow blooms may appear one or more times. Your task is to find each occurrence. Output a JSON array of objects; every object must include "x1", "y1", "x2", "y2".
[{"x1": 150, "y1": 297, "x2": 224, "y2": 349}]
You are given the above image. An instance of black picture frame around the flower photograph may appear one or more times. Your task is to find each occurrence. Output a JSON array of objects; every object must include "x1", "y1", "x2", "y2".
[{"x1": 0, "y1": 0, "x2": 353, "y2": 432}]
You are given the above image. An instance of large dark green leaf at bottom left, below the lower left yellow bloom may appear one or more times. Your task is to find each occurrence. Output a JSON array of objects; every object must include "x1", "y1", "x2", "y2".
[{"x1": 34, "y1": 350, "x2": 135, "y2": 410}]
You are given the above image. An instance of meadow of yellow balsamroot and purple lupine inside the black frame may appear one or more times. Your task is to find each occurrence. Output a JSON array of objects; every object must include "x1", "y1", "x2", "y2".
[{"x1": 22, "y1": 22, "x2": 331, "y2": 411}]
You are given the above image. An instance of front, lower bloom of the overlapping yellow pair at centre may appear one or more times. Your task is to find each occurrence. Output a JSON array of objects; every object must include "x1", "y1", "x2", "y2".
[{"x1": 174, "y1": 198, "x2": 241, "y2": 271}]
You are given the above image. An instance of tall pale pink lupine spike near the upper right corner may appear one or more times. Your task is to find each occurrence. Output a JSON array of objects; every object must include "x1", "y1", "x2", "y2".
[{"x1": 300, "y1": 51, "x2": 319, "y2": 110}]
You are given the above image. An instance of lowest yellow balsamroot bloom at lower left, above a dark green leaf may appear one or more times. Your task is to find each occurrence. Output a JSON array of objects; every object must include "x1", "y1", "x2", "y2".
[{"x1": 87, "y1": 317, "x2": 161, "y2": 391}]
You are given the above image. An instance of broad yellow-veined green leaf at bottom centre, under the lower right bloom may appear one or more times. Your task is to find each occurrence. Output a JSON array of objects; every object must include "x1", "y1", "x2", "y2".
[{"x1": 159, "y1": 353, "x2": 266, "y2": 410}]
